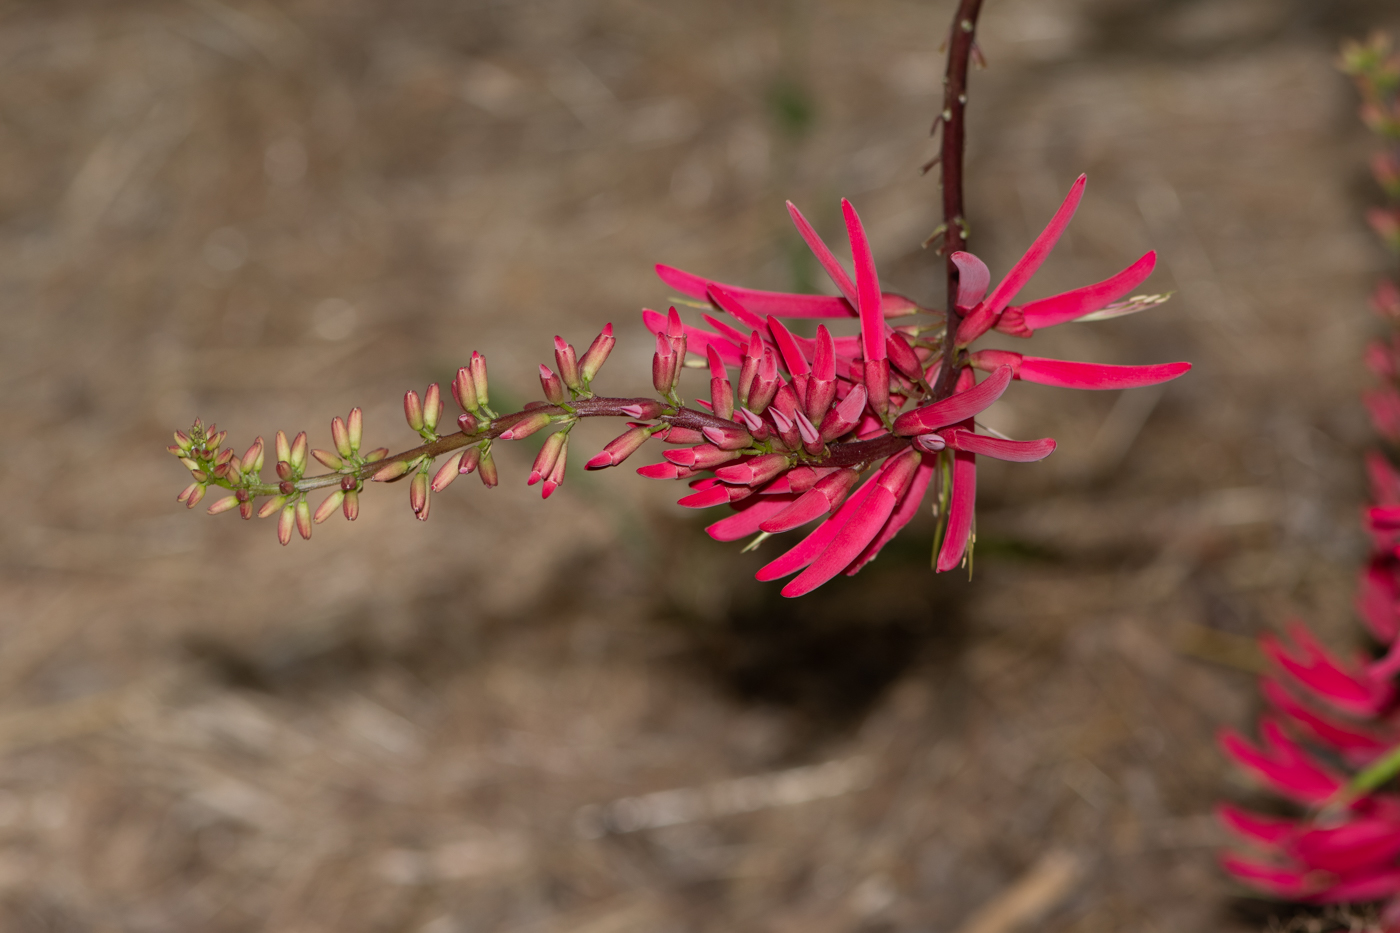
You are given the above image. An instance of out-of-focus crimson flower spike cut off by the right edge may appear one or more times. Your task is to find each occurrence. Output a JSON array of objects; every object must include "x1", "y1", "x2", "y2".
[{"x1": 1219, "y1": 30, "x2": 1400, "y2": 930}]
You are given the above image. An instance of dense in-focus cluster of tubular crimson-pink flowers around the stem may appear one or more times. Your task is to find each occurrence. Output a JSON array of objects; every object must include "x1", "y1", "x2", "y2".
[{"x1": 643, "y1": 177, "x2": 1190, "y2": 597}]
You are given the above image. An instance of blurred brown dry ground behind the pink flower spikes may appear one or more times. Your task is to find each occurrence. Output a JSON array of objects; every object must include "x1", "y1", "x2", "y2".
[{"x1": 0, "y1": 0, "x2": 1400, "y2": 933}]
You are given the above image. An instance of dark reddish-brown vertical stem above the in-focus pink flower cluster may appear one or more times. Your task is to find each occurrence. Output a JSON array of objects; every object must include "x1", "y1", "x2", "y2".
[{"x1": 934, "y1": 0, "x2": 981, "y2": 399}]
